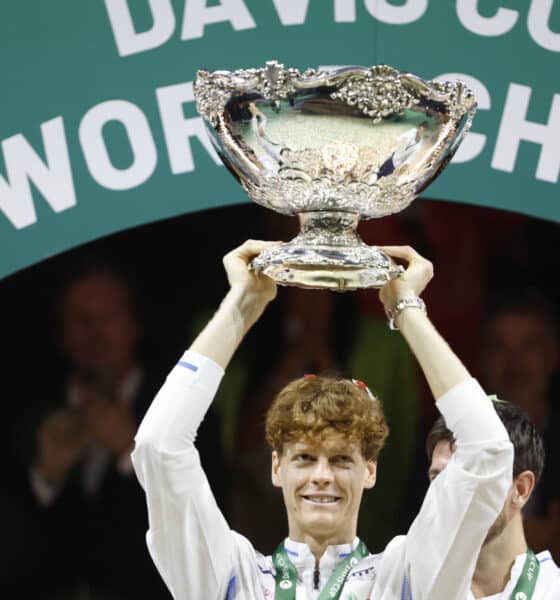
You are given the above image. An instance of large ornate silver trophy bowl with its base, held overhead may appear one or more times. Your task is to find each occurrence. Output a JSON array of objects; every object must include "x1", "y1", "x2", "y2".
[{"x1": 194, "y1": 61, "x2": 476, "y2": 291}]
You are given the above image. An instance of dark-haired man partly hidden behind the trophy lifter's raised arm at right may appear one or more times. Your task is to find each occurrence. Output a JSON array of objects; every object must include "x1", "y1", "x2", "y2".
[{"x1": 426, "y1": 401, "x2": 560, "y2": 600}]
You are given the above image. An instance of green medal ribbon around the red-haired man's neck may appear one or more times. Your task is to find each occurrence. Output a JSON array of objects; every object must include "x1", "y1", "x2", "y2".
[{"x1": 272, "y1": 540, "x2": 370, "y2": 600}]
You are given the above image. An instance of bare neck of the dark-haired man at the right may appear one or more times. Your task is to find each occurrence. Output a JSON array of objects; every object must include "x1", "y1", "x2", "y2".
[{"x1": 471, "y1": 514, "x2": 527, "y2": 598}]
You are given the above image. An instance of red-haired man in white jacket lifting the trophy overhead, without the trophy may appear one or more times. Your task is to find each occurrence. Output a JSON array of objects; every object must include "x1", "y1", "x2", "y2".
[{"x1": 133, "y1": 241, "x2": 512, "y2": 600}]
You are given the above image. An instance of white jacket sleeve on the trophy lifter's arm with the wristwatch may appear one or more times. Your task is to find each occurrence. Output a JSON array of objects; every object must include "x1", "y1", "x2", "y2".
[{"x1": 405, "y1": 379, "x2": 513, "y2": 600}]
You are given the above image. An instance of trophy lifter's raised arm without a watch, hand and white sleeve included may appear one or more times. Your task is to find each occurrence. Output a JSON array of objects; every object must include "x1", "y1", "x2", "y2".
[{"x1": 132, "y1": 241, "x2": 276, "y2": 599}]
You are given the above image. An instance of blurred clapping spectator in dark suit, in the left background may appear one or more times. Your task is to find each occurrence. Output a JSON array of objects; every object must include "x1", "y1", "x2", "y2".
[{"x1": 19, "y1": 265, "x2": 224, "y2": 600}]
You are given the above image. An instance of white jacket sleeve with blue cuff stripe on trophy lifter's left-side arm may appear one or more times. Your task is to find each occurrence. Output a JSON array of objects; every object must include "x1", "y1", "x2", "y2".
[{"x1": 132, "y1": 352, "x2": 235, "y2": 600}]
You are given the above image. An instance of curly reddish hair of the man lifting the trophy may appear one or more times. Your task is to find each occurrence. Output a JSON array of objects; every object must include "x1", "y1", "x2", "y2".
[{"x1": 265, "y1": 376, "x2": 389, "y2": 460}]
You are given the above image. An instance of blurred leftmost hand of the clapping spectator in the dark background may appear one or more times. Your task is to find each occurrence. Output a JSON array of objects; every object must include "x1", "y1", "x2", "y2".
[{"x1": 37, "y1": 411, "x2": 87, "y2": 483}]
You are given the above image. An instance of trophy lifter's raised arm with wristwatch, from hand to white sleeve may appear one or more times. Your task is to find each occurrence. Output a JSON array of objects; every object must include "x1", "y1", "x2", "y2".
[{"x1": 380, "y1": 247, "x2": 513, "y2": 600}]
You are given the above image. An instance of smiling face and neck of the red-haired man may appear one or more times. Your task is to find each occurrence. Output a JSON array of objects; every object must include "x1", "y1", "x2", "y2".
[{"x1": 272, "y1": 436, "x2": 377, "y2": 544}]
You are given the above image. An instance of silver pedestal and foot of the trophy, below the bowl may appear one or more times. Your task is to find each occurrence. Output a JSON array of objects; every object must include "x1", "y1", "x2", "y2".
[{"x1": 250, "y1": 211, "x2": 403, "y2": 292}]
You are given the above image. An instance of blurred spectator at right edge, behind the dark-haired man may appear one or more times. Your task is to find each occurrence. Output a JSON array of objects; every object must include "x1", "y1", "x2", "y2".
[{"x1": 481, "y1": 289, "x2": 560, "y2": 560}]
